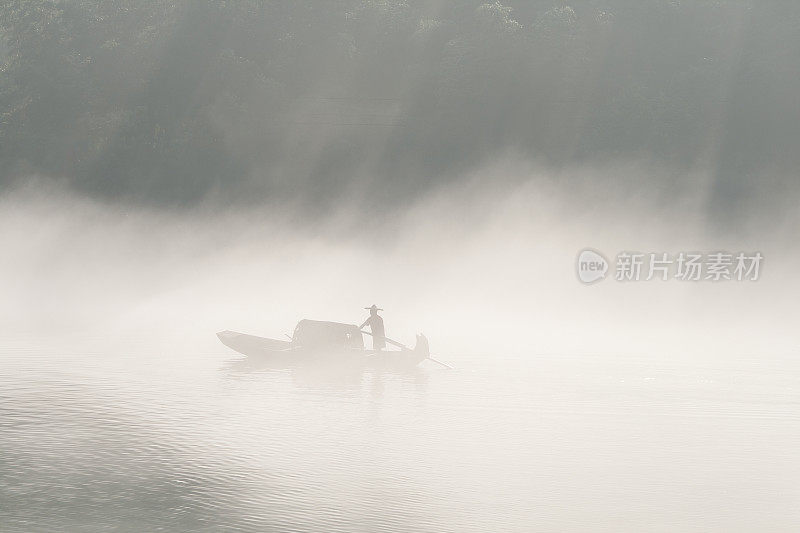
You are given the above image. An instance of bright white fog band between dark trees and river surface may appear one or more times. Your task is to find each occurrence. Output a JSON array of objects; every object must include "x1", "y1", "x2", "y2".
[{"x1": 0, "y1": 157, "x2": 797, "y2": 360}]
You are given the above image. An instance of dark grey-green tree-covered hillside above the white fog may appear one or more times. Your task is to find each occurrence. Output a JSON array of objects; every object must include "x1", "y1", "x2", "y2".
[{"x1": 0, "y1": 0, "x2": 800, "y2": 204}]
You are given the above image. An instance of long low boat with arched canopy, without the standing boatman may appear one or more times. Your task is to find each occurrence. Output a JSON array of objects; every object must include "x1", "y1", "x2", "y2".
[{"x1": 217, "y1": 320, "x2": 430, "y2": 368}]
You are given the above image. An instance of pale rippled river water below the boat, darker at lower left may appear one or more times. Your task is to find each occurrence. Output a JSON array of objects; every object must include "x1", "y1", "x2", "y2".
[{"x1": 0, "y1": 334, "x2": 800, "y2": 533}]
